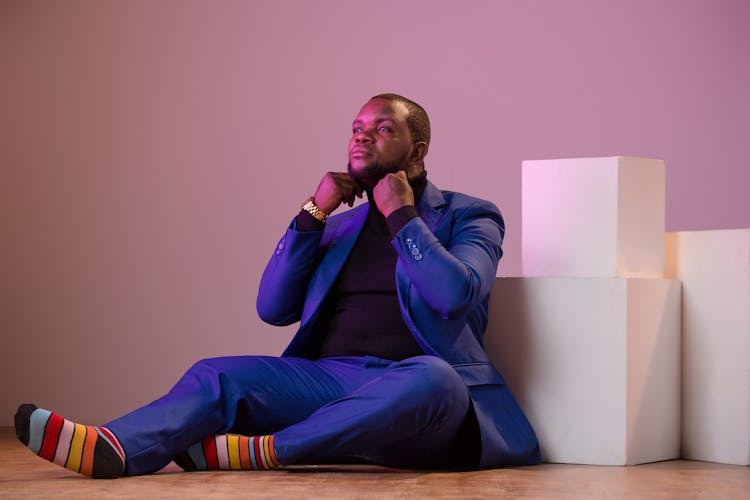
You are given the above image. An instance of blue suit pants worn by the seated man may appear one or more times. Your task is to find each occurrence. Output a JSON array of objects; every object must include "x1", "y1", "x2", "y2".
[{"x1": 105, "y1": 356, "x2": 471, "y2": 476}]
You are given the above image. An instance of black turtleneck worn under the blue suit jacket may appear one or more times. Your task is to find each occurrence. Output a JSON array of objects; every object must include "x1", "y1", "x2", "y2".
[{"x1": 297, "y1": 173, "x2": 427, "y2": 361}]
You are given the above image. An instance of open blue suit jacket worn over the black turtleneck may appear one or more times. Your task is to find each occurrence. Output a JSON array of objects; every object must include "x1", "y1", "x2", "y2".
[{"x1": 257, "y1": 182, "x2": 540, "y2": 468}]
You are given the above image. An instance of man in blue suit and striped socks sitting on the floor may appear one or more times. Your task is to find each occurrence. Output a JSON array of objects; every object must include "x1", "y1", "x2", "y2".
[{"x1": 16, "y1": 94, "x2": 540, "y2": 477}]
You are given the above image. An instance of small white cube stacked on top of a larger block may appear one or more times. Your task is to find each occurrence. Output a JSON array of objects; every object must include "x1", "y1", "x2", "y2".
[{"x1": 522, "y1": 157, "x2": 665, "y2": 278}]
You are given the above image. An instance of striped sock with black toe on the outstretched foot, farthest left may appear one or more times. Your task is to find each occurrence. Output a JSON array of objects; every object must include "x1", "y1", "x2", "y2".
[{"x1": 15, "y1": 404, "x2": 125, "y2": 479}]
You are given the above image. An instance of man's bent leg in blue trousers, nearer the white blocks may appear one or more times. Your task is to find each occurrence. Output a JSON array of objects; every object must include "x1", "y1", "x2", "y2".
[{"x1": 178, "y1": 356, "x2": 472, "y2": 470}]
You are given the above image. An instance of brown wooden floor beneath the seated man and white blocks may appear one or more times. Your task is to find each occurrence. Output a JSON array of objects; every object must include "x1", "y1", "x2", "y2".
[{"x1": 0, "y1": 428, "x2": 750, "y2": 500}]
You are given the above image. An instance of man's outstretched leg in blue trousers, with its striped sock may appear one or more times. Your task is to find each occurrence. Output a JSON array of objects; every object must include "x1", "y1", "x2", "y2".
[{"x1": 16, "y1": 356, "x2": 362, "y2": 477}]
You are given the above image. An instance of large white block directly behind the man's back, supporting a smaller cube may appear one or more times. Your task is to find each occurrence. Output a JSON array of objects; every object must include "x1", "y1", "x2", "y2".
[{"x1": 484, "y1": 278, "x2": 680, "y2": 465}]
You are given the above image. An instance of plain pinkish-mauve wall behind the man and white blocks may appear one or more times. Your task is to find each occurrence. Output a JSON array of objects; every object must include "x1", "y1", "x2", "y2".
[{"x1": 0, "y1": 0, "x2": 750, "y2": 425}]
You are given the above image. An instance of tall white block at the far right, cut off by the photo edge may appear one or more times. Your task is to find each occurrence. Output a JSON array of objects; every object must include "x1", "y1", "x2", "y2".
[{"x1": 665, "y1": 229, "x2": 750, "y2": 465}]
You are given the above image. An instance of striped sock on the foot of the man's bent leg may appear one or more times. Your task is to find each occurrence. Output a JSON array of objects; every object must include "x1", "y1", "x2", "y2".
[{"x1": 174, "y1": 434, "x2": 281, "y2": 471}]
